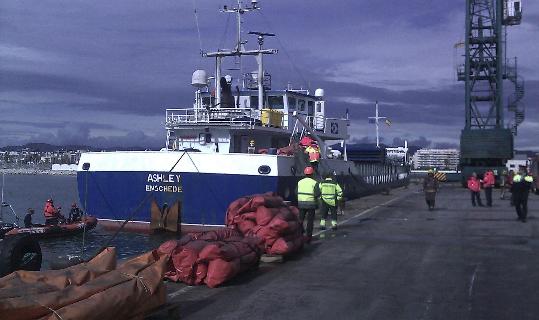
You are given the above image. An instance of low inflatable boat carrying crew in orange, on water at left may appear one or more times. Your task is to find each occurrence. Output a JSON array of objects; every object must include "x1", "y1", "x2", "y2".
[{"x1": 5, "y1": 216, "x2": 97, "y2": 239}]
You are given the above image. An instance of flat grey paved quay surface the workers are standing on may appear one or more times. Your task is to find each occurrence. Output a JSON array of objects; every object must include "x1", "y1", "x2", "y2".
[{"x1": 147, "y1": 184, "x2": 539, "y2": 320}]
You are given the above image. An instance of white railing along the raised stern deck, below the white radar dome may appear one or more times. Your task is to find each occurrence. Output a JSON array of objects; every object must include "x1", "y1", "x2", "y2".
[{"x1": 166, "y1": 108, "x2": 260, "y2": 127}]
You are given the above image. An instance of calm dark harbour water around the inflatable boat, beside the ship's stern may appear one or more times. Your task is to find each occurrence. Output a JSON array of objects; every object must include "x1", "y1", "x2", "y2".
[{"x1": 0, "y1": 174, "x2": 176, "y2": 269}]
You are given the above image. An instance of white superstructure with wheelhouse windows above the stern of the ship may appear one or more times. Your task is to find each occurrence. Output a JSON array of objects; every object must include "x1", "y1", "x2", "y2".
[{"x1": 166, "y1": 89, "x2": 348, "y2": 153}]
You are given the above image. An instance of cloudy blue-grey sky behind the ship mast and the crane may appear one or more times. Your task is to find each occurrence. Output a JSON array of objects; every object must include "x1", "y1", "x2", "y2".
[{"x1": 0, "y1": 0, "x2": 539, "y2": 150}]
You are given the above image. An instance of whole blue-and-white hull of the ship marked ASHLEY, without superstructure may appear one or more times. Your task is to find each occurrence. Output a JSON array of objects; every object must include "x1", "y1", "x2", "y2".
[{"x1": 77, "y1": 152, "x2": 408, "y2": 231}]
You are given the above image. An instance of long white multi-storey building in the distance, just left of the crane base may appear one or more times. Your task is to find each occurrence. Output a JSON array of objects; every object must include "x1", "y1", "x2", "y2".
[{"x1": 413, "y1": 149, "x2": 459, "y2": 170}]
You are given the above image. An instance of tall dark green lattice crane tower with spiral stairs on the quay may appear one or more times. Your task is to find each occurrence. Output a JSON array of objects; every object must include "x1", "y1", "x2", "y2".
[{"x1": 457, "y1": 0, "x2": 524, "y2": 181}]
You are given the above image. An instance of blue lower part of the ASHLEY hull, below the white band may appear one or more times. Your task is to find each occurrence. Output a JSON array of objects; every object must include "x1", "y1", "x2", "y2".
[{"x1": 77, "y1": 171, "x2": 408, "y2": 231}]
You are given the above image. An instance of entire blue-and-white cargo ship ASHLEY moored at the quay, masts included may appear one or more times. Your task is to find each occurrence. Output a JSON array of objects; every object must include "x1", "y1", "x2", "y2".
[{"x1": 77, "y1": 1, "x2": 408, "y2": 231}]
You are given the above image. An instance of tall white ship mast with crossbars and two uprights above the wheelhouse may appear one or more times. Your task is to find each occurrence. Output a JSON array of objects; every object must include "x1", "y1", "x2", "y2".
[{"x1": 202, "y1": 0, "x2": 277, "y2": 109}]
